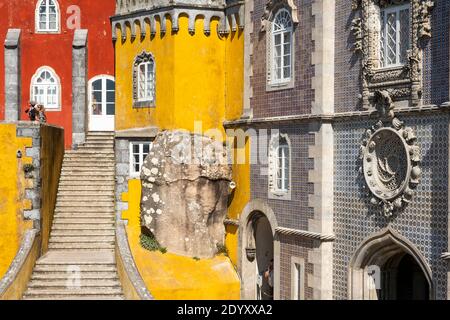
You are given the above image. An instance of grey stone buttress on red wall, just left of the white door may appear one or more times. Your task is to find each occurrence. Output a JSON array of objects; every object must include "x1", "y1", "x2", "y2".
[{"x1": 72, "y1": 29, "x2": 88, "y2": 148}]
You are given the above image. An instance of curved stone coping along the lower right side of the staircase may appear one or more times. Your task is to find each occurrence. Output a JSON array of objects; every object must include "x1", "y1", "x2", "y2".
[{"x1": 116, "y1": 220, "x2": 154, "y2": 300}]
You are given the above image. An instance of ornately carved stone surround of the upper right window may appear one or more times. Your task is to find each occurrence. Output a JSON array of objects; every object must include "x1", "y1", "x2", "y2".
[{"x1": 351, "y1": 0, "x2": 434, "y2": 109}]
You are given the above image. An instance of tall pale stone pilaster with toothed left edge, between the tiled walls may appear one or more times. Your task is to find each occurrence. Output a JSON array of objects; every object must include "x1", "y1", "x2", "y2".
[{"x1": 308, "y1": 0, "x2": 335, "y2": 300}]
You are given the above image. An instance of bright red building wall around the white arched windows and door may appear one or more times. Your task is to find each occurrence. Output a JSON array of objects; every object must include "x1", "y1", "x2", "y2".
[{"x1": 0, "y1": 0, "x2": 115, "y2": 148}]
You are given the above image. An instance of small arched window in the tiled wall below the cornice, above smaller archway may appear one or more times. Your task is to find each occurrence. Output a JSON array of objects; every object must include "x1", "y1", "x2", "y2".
[{"x1": 269, "y1": 135, "x2": 291, "y2": 200}]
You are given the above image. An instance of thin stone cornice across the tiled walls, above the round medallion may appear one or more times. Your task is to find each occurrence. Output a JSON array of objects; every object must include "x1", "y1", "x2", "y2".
[{"x1": 224, "y1": 102, "x2": 450, "y2": 128}]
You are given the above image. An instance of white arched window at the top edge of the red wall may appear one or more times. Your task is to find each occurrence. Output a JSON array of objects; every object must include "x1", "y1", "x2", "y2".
[{"x1": 36, "y1": 0, "x2": 60, "y2": 32}]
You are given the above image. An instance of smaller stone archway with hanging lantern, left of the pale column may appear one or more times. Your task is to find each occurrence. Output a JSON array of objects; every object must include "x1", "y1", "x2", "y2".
[{"x1": 238, "y1": 200, "x2": 280, "y2": 300}]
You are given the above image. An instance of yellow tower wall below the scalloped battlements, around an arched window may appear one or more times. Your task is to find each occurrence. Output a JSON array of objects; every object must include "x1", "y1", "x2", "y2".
[{"x1": 116, "y1": 15, "x2": 244, "y2": 132}]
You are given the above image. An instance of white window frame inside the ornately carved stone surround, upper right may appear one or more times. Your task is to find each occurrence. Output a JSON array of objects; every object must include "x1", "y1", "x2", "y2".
[{"x1": 378, "y1": 3, "x2": 411, "y2": 69}]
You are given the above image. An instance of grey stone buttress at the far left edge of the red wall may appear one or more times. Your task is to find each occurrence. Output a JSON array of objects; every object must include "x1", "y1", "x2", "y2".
[{"x1": 5, "y1": 29, "x2": 21, "y2": 121}]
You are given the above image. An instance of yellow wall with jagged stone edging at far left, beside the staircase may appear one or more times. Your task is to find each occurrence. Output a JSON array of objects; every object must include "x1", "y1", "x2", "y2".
[{"x1": 0, "y1": 124, "x2": 32, "y2": 278}]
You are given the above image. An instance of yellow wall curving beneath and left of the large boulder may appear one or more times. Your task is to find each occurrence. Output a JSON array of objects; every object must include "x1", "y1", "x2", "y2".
[{"x1": 122, "y1": 179, "x2": 240, "y2": 300}]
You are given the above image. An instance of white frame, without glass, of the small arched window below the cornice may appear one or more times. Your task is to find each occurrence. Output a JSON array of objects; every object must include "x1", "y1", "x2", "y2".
[{"x1": 268, "y1": 134, "x2": 292, "y2": 200}]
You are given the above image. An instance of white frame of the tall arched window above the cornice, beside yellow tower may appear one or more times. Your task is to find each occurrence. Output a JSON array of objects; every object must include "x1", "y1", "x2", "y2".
[{"x1": 270, "y1": 8, "x2": 294, "y2": 86}]
